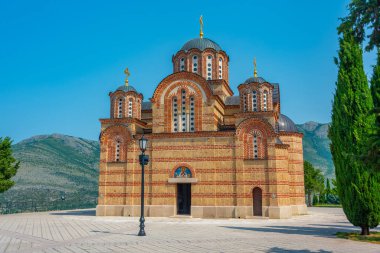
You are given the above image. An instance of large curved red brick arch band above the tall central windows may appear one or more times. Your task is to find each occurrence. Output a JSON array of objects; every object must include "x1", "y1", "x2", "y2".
[{"x1": 151, "y1": 71, "x2": 212, "y2": 106}]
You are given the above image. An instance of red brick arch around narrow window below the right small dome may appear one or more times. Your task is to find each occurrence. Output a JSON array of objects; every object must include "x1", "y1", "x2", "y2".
[{"x1": 236, "y1": 118, "x2": 276, "y2": 159}]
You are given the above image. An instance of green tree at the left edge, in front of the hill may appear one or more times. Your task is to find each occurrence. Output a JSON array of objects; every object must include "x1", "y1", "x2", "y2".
[{"x1": 0, "y1": 137, "x2": 20, "y2": 193}]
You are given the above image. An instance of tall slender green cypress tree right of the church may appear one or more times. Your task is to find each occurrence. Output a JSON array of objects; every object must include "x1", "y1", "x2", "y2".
[{"x1": 329, "y1": 32, "x2": 380, "y2": 235}]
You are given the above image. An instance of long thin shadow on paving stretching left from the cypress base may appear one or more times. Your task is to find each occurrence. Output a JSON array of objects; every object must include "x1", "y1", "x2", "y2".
[{"x1": 222, "y1": 226, "x2": 353, "y2": 237}]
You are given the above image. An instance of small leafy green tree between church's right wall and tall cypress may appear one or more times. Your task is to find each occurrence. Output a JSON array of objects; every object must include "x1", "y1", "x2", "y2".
[{"x1": 303, "y1": 161, "x2": 325, "y2": 206}]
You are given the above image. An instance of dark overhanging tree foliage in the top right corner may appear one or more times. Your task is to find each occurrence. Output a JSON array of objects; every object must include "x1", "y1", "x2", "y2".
[{"x1": 338, "y1": 0, "x2": 380, "y2": 51}]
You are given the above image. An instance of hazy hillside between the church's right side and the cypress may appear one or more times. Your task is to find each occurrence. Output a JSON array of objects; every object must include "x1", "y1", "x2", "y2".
[{"x1": 297, "y1": 121, "x2": 335, "y2": 178}]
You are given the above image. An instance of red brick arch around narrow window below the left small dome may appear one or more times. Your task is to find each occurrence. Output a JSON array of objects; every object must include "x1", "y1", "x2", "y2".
[{"x1": 100, "y1": 125, "x2": 132, "y2": 162}]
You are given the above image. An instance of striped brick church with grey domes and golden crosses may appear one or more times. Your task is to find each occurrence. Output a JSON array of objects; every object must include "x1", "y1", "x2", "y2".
[{"x1": 96, "y1": 20, "x2": 307, "y2": 219}]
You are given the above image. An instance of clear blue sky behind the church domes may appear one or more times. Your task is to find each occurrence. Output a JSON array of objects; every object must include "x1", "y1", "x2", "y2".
[{"x1": 0, "y1": 0, "x2": 375, "y2": 142}]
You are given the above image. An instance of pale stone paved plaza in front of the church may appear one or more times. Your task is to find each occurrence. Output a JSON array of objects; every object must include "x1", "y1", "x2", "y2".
[{"x1": 0, "y1": 208, "x2": 380, "y2": 253}]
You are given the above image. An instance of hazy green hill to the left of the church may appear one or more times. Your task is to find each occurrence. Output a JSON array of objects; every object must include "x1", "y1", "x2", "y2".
[{"x1": 0, "y1": 134, "x2": 99, "y2": 211}]
